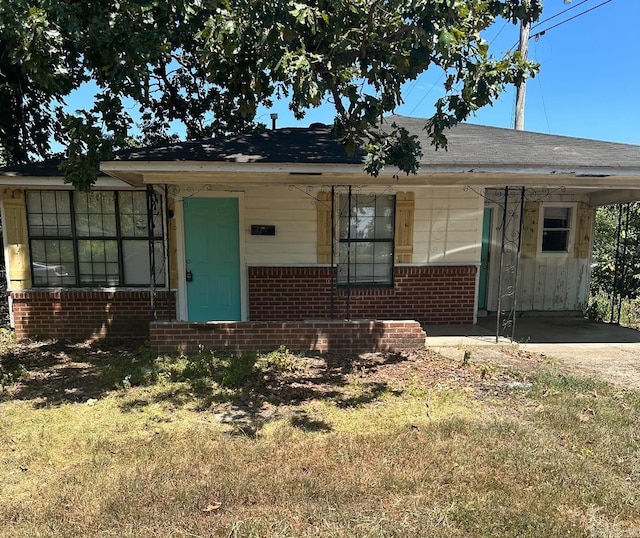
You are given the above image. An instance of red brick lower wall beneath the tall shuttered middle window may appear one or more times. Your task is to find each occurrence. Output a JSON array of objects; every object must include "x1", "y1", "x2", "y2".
[{"x1": 249, "y1": 266, "x2": 476, "y2": 324}]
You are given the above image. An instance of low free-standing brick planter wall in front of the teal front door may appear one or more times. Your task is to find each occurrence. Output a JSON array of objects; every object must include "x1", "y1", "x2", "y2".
[{"x1": 149, "y1": 321, "x2": 426, "y2": 353}]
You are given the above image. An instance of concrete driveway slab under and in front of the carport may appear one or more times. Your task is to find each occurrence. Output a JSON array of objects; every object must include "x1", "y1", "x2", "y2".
[{"x1": 426, "y1": 317, "x2": 640, "y2": 389}]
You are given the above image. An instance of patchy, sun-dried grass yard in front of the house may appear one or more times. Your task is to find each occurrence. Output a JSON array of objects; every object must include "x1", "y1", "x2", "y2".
[{"x1": 0, "y1": 334, "x2": 640, "y2": 537}]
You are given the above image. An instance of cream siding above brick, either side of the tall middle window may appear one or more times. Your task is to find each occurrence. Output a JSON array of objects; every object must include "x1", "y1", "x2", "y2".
[{"x1": 244, "y1": 186, "x2": 483, "y2": 265}]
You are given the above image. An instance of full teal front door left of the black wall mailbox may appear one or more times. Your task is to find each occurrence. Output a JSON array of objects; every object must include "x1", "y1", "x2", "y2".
[{"x1": 184, "y1": 198, "x2": 241, "y2": 321}]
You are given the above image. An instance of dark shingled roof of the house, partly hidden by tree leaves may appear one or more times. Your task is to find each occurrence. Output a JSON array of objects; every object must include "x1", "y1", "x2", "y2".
[{"x1": 0, "y1": 116, "x2": 640, "y2": 176}]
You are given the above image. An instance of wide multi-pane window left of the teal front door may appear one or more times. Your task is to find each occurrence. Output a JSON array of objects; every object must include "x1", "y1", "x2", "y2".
[{"x1": 27, "y1": 191, "x2": 164, "y2": 286}]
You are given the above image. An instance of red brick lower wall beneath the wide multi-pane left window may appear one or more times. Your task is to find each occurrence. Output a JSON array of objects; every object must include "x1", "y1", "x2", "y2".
[{"x1": 10, "y1": 289, "x2": 176, "y2": 340}]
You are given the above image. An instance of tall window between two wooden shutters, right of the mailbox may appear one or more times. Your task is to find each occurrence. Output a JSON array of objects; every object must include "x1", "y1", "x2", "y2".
[{"x1": 338, "y1": 194, "x2": 395, "y2": 286}]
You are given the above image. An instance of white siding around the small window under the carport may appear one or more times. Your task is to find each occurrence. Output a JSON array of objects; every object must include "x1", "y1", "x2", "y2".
[{"x1": 487, "y1": 194, "x2": 591, "y2": 312}]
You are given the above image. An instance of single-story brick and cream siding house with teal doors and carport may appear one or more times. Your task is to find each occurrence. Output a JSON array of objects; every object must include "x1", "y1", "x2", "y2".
[{"x1": 0, "y1": 116, "x2": 640, "y2": 350}]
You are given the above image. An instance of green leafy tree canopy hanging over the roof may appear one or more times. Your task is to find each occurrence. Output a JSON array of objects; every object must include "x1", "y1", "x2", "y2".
[{"x1": 0, "y1": 0, "x2": 542, "y2": 188}]
